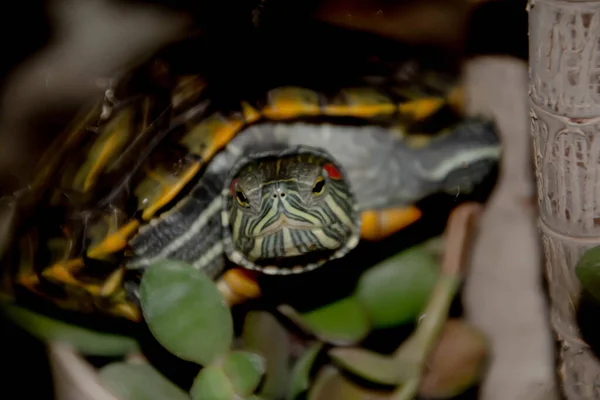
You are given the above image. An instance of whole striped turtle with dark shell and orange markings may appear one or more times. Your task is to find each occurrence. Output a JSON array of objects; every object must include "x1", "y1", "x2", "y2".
[{"x1": 3, "y1": 57, "x2": 502, "y2": 321}]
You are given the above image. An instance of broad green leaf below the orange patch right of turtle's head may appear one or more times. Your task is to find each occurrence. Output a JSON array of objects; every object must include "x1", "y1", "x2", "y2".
[{"x1": 355, "y1": 246, "x2": 438, "y2": 328}]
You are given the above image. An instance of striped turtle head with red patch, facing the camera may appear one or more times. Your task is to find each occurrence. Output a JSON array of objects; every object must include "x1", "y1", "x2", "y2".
[{"x1": 224, "y1": 148, "x2": 360, "y2": 274}]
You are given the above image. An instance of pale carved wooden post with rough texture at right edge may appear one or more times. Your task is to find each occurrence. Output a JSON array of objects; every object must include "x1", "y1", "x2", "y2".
[{"x1": 529, "y1": 0, "x2": 600, "y2": 400}]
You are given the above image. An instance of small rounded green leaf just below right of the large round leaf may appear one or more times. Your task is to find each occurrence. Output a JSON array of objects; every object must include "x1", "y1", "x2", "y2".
[{"x1": 223, "y1": 351, "x2": 265, "y2": 397}]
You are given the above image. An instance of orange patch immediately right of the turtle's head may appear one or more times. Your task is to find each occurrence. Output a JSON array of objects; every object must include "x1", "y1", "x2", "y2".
[{"x1": 360, "y1": 206, "x2": 422, "y2": 240}]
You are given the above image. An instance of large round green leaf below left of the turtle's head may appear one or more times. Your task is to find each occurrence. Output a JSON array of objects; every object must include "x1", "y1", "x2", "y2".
[{"x1": 140, "y1": 261, "x2": 233, "y2": 365}]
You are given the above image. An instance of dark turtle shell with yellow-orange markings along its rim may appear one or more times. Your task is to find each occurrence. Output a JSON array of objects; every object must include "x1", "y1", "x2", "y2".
[{"x1": 4, "y1": 52, "x2": 495, "y2": 320}]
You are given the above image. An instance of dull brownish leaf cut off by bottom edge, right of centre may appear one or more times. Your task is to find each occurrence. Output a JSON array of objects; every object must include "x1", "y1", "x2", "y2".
[{"x1": 308, "y1": 366, "x2": 389, "y2": 400}]
